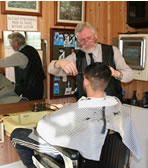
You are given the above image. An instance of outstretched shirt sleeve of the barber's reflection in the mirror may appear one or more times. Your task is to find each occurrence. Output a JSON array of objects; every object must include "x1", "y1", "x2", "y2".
[{"x1": 0, "y1": 52, "x2": 29, "y2": 69}]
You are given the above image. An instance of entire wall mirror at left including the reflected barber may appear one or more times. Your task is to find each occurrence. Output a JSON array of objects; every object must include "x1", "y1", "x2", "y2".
[{"x1": 0, "y1": 31, "x2": 47, "y2": 104}]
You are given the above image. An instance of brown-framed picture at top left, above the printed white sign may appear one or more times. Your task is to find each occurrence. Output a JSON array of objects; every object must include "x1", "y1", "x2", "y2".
[{"x1": 1, "y1": 1, "x2": 42, "y2": 16}]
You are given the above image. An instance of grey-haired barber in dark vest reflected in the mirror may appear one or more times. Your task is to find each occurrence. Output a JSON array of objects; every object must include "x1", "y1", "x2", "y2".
[{"x1": 0, "y1": 32, "x2": 45, "y2": 100}]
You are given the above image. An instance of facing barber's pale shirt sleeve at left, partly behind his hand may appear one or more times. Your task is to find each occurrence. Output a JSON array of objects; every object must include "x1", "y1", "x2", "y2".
[{"x1": 48, "y1": 53, "x2": 76, "y2": 76}]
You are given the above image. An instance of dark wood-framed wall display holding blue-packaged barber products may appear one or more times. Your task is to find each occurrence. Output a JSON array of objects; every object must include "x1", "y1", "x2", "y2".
[{"x1": 50, "y1": 28, "x2": 79, "y2": 99}]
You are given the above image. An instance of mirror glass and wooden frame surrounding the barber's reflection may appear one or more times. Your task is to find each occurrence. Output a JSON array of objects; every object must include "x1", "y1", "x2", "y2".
[{"x1": 0, "y1": 31, "x2": 47, "y2": 104}]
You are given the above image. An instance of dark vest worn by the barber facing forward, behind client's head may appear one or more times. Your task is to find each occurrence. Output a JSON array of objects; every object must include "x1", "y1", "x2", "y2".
[{"x1": 76, "y1": 44, "x2": 122, "y2": 102}]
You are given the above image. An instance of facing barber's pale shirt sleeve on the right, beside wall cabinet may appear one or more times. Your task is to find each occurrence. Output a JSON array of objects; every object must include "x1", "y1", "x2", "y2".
[{"x1": 113, "y1": 46, "x2": 133, "y2": 83}]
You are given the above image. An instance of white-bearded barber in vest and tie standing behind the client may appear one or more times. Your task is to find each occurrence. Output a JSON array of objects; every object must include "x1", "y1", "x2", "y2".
[{"x1": 48, "y1": 23, "x2": 133, "y2": 101}]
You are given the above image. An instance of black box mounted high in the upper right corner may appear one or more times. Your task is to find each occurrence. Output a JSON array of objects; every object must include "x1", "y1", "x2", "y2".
[{"x1": 127, "y1": 1, "x2": 148, "y2": 28}]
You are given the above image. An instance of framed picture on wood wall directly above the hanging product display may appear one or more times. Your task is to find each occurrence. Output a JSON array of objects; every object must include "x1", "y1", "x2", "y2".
[{"x1": 54, "y1": 1, "x2": 85, "y2": 26}]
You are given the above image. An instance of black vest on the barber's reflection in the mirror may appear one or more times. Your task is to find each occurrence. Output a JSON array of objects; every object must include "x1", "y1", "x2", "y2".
[{"x1": 15, "y1": 45, "x2": 45, "y2": 100}]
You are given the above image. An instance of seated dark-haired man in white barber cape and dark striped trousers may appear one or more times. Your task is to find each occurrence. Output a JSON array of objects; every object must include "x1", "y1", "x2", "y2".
[{"x1": 11, "y1": 62, "x2": 141, "y2": 168}]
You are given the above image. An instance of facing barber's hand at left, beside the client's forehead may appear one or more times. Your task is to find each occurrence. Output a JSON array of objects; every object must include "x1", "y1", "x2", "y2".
[{"x1": 55, "y1": 59, "x2": 78, "y2": 76}]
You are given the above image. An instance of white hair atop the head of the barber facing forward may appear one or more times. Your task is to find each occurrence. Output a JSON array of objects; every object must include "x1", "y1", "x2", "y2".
[{"x1": 75, "y1": 22, "x2": 96, "y2": 37}]
